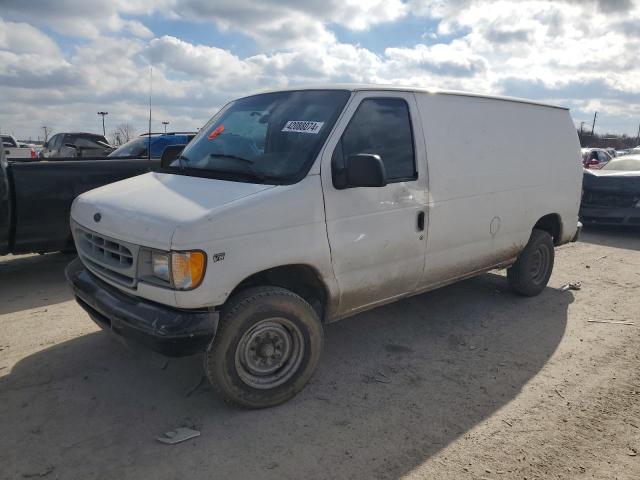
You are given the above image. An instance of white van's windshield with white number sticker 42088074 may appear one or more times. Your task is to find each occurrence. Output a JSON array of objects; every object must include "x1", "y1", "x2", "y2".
[{"x1": 161, "y1": 90, "x2": 350, "y2": 184}]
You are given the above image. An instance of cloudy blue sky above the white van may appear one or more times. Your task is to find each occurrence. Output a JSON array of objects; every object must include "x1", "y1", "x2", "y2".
[{"x1": 0, "y1": 0, "x2": 640, "y2": 139}]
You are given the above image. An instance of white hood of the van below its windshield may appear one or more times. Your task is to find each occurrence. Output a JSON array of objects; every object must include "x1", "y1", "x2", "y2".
[{"x1": 71, "y1": 172, "x2": 273, "y2": 250}]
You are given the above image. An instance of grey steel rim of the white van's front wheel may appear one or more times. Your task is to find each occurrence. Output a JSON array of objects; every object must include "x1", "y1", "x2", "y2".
[{"x1": 235, "y1": 317, "x2": 304, "y2": 390}]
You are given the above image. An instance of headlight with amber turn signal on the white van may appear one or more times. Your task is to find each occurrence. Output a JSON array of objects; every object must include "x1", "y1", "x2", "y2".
[{"x1": 151, "y1": 250, "x2": 207, "y2": 290}]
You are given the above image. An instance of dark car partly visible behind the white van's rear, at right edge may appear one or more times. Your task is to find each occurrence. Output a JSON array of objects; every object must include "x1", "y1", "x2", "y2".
[{"x1": 580, "y1": 155, "x2": 640, "y2": 225}]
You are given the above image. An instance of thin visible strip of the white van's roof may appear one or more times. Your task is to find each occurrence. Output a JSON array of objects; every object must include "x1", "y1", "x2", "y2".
[{"x1": 246, "y1": 83, "x2": 569, "y2": 110}]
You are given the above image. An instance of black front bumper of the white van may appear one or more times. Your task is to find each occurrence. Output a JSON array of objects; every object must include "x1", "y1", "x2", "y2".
[{"x1": 65, "y1": 259, "x2": 218, "y2": 357}]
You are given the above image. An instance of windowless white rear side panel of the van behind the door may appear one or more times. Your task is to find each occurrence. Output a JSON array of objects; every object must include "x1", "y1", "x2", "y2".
[{"x1": 416, "y1": 93, "x2": 581, "y2": 288}]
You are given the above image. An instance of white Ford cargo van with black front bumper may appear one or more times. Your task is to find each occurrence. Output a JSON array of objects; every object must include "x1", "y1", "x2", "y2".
[{"x1": 67, "y1": 85, "x2": 582, "y2": 408}]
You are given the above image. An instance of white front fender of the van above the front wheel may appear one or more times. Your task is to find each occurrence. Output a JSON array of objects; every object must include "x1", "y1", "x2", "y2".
[{"x1": 171, "y1": 175, "x2": 338, "y2": 308}]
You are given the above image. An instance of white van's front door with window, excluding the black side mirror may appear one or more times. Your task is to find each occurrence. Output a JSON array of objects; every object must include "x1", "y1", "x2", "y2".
[{"x1": 321, "y1": 91, "x2": 427, "y2": 315}]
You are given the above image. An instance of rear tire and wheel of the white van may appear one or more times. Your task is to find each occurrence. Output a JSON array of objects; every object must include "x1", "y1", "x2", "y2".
[{"x1": 507, "y1": 229, "x2": 554, "y2": 297}]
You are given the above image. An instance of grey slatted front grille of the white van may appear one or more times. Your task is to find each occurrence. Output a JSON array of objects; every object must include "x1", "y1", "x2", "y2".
[{"x1": 73, "y1": 225, "x2": 139, "y2": 288}]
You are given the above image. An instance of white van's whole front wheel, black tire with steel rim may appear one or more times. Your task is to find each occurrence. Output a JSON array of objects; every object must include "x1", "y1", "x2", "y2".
[{"x1": 205, "y1": 287, "x2": 323, "y2": 408}]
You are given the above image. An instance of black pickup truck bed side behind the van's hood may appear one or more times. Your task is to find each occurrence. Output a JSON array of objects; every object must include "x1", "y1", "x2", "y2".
[{"x1": 0, "y1": 151, "x2": 153, "y2": 255}]
